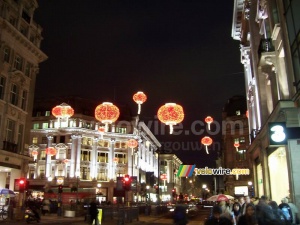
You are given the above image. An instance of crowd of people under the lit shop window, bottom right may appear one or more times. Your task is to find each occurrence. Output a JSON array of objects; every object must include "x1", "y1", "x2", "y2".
[{"x1": 205, "y1": 196, "x2": 299, "y2": 225}]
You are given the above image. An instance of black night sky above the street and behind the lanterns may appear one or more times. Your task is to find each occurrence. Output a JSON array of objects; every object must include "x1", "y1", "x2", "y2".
[{"x1": 34, "y1": 0, "x2": 245, "y2": 167}]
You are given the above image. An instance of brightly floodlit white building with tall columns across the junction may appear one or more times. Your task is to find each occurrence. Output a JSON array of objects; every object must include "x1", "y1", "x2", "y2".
[{"x1": 26, "y1": 98, "x2": 161, "y2": 203}]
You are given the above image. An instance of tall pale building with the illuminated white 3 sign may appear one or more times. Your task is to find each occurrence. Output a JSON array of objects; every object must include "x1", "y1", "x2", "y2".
[{"x1": 232, "y1": 0, "x2": 300, "y2": 207}]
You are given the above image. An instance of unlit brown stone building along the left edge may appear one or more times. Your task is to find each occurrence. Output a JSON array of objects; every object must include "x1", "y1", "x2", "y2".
[{"x1": 0, "y1": 0, "x2": 47, "y2": 190}]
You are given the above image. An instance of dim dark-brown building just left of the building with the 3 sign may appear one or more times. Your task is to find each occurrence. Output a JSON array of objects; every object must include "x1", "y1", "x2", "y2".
[{"x1": 221, "y1": 96, "x2": 254, "y2": 196}]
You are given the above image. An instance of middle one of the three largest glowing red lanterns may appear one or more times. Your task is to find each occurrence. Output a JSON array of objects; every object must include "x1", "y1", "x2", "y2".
[{"x1": 95, "y1": 102, "x2": 120, "y2": 132}]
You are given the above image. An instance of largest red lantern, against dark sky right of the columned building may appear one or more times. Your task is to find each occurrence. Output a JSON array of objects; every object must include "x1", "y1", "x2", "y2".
[{"x1": 157, "y1": 103, "x2": 184, "y2": 134}]
